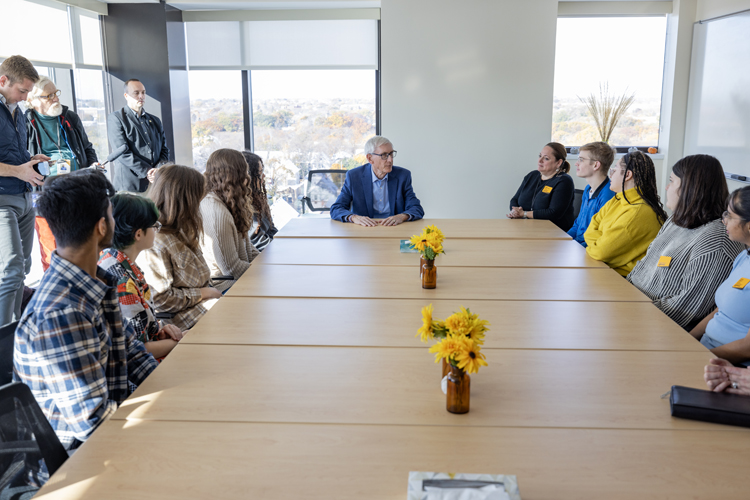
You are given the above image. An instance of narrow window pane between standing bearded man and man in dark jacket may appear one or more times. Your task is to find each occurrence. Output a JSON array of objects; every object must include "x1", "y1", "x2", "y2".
[{"x1": 75, "y1": 69, "x2": 109, "y2": 162}]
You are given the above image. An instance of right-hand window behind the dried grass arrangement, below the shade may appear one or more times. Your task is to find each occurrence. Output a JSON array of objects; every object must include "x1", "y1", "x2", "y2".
[{"x1": 552, "y1": 17, "x2": 667, "y2": 147}]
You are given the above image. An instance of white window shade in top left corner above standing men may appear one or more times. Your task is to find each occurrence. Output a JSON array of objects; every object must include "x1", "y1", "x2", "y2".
[{"x1": 0, "y1": 0, "x2": 72, "y2": 66}]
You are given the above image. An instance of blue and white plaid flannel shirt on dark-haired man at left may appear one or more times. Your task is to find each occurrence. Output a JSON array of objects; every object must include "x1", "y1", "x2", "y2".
[{"x1": 13, "y1": 252, "x2": 157, "y2": 449}]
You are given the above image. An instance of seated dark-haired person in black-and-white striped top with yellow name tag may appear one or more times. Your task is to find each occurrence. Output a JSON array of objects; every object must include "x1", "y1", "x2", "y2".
[{"x1": 627, "y1": 155, "x2": 743, "y2": 330}]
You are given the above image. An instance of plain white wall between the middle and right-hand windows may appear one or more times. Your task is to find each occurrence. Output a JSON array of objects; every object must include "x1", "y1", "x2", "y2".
[{"x1": 381, "y1": 0, "x2": 560, "y2": 218}]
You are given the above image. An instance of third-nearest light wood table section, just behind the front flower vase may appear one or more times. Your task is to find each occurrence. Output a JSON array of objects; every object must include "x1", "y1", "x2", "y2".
[{"x1": 187, "y1": 297, "x2": 708, "y2": 353}]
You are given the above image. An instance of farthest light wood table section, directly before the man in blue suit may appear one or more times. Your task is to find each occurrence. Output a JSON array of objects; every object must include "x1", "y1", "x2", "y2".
[{"x1": 274, "y1": 218, "x2": 571, "y2": 241}]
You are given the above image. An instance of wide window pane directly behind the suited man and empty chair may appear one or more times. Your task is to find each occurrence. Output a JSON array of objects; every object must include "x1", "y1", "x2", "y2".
[{"x1": 252, "y1": 70, "x2": 375, "y2": 212}]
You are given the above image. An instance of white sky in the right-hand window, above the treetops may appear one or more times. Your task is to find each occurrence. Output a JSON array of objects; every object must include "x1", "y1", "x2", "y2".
[{"x1": 554, "y1": 16, "x2": 667, "y2": 99}]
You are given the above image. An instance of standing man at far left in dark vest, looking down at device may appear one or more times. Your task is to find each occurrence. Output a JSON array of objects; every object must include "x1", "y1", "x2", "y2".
[{"x1": 0, "y1": 56, "x2": 49, "y2": 326}]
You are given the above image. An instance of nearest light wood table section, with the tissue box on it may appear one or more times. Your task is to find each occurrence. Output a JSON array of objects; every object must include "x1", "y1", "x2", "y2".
[{"x1": 35, "y1": 420, "x2": 750, "y2": 500}]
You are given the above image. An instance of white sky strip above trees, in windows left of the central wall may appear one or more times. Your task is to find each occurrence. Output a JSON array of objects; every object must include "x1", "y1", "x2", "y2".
[{"x1": 188, "y1": 70, "x2": 375, "y2": 100}]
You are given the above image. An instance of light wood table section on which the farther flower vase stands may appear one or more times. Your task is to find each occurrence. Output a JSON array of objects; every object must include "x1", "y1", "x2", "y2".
[{"x1": 227, "y1": 265, "x2": 651, "y2": 302}]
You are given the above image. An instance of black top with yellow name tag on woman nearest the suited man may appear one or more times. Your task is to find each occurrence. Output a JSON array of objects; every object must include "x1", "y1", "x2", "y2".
[{"x1": 510, "y1": 170, "x2": 575, "y2": 232}]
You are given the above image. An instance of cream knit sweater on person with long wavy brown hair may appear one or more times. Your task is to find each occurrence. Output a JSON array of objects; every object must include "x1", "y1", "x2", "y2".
[{"x1": 200, "y1": 193, "x2": 259, "y2": 289}]
